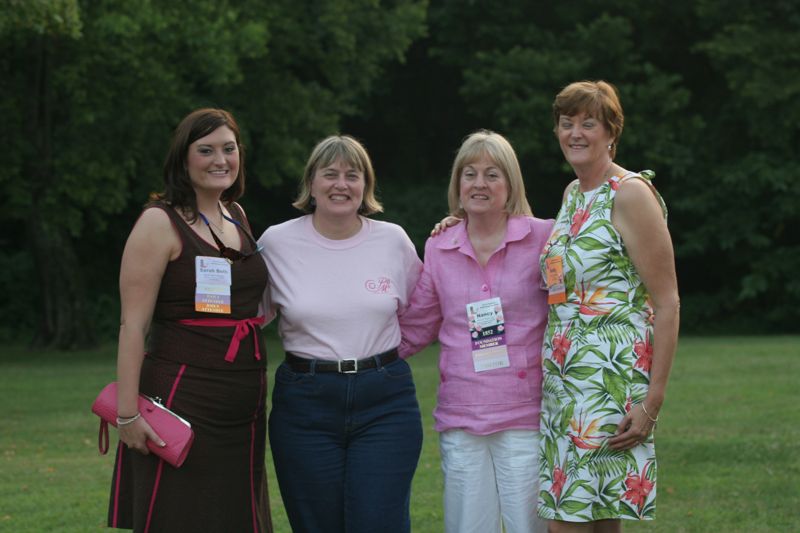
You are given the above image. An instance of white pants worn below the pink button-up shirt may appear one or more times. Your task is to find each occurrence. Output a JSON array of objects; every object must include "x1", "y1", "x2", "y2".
[{"x1": 439, "y1": 429, "x2": 547, "y2": 533}]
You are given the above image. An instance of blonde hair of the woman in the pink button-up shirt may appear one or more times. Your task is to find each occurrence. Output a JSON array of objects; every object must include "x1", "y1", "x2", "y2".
[{"x1": 447, "y1": 130, "x2": 533, "y2": 218}]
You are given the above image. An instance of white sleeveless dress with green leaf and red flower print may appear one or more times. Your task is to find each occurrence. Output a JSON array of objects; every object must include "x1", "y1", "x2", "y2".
[{"x1": 539, "y1": 171, "x2": 666, "y2": 522}]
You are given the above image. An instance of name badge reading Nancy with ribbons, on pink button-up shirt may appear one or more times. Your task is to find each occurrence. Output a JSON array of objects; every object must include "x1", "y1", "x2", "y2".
[{"x1": 467, "y1": 298, "x2": 511, "y2": 372}]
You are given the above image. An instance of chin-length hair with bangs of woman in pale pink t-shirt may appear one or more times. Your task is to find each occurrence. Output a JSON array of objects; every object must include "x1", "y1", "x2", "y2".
[{"x1": 292, "y1": 135, "x2": 383, "y2": 215}]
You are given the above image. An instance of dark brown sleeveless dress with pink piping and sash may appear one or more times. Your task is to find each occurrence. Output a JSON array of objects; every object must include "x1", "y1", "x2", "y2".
[{"x1": 108, "y1": 203, "x2": 272, "y2": 533}]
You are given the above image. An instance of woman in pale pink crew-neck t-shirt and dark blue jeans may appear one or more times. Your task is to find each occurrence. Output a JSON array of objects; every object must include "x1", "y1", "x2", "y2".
[{"x1": 259, "y1": 136, "x2": 422, "y2": 533}]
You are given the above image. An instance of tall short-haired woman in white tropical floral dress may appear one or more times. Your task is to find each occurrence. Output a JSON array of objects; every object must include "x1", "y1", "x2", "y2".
[{"x1": 539, "y1": 81, "x2": 679, "y2": 532}]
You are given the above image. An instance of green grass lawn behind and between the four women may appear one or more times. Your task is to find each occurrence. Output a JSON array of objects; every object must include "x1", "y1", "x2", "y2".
[{"x1": 0, "y1": 337, "x2": 800, "y2": 533}]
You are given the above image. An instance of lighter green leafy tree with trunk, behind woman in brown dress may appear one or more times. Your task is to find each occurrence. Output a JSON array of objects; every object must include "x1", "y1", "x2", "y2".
[{"x1": 0, "y1": 0, "x2": 426, "y2": 347}]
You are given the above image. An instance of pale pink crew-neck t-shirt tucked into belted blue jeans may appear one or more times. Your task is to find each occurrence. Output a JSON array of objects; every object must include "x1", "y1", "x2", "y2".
[{"x1": 258, "y1": 215, "x2": 422, "y2": 360}]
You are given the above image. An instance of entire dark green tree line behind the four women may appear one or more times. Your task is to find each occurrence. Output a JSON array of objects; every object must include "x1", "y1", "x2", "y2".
[{"x1": 0, "y1": 0, "x2": 800, "y2": 348}]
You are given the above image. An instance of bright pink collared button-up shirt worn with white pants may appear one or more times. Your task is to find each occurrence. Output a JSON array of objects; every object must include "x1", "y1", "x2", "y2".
[{"x1": 400, "y1": 216, "x2": 553, "y2": 435}]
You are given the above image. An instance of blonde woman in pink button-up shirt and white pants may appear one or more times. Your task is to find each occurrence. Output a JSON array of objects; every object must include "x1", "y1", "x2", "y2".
[{"x1": 400, "y1": 130, "x2": 552, "y2": 533}]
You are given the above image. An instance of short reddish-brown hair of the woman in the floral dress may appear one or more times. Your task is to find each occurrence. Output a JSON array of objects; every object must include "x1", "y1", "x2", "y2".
[{"x1": 553, "y1": 80, "x2": 625, "y2": 159}]
